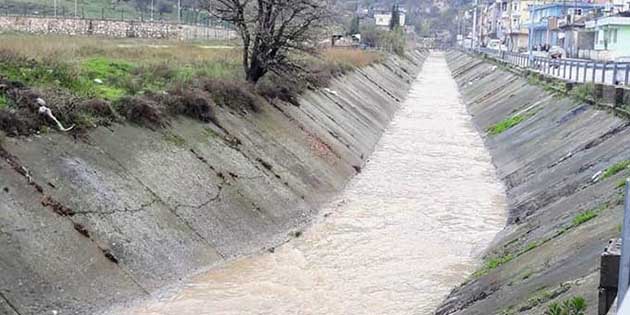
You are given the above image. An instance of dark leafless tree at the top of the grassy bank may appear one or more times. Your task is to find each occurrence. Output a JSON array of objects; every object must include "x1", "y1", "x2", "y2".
[{"x1": 205, "y1": 0, "x2": 330, "y2": 82}]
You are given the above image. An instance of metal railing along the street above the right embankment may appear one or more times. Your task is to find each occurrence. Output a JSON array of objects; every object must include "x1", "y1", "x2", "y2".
[{"x1": 475, "y1": 48, "x2": 630, "y2": 85}]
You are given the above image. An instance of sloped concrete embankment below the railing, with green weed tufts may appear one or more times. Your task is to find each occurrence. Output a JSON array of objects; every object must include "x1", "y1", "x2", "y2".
[{"x1": 436, "y1": 52, "x2": 630, "y2": 315}]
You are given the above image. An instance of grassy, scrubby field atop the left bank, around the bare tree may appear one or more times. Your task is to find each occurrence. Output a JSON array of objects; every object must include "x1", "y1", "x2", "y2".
[{"x1": 0, "y1": 34, "x2": 382, "y2": 135}]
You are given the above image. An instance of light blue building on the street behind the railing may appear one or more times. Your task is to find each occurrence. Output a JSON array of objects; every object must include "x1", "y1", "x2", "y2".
[{"x1": 527, "y1": 1, "x2": 605, "y2": 50}]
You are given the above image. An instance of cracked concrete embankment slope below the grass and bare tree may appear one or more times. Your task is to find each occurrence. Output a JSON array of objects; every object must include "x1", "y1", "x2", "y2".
[{"x1": 0, "y1": 52, "x2": 425, "y2": 315}]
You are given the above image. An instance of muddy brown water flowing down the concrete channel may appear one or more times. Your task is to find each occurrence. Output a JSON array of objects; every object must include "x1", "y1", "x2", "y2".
[{"x1": 125, "y1": 53, "x2": 505, "y2": 315}]
